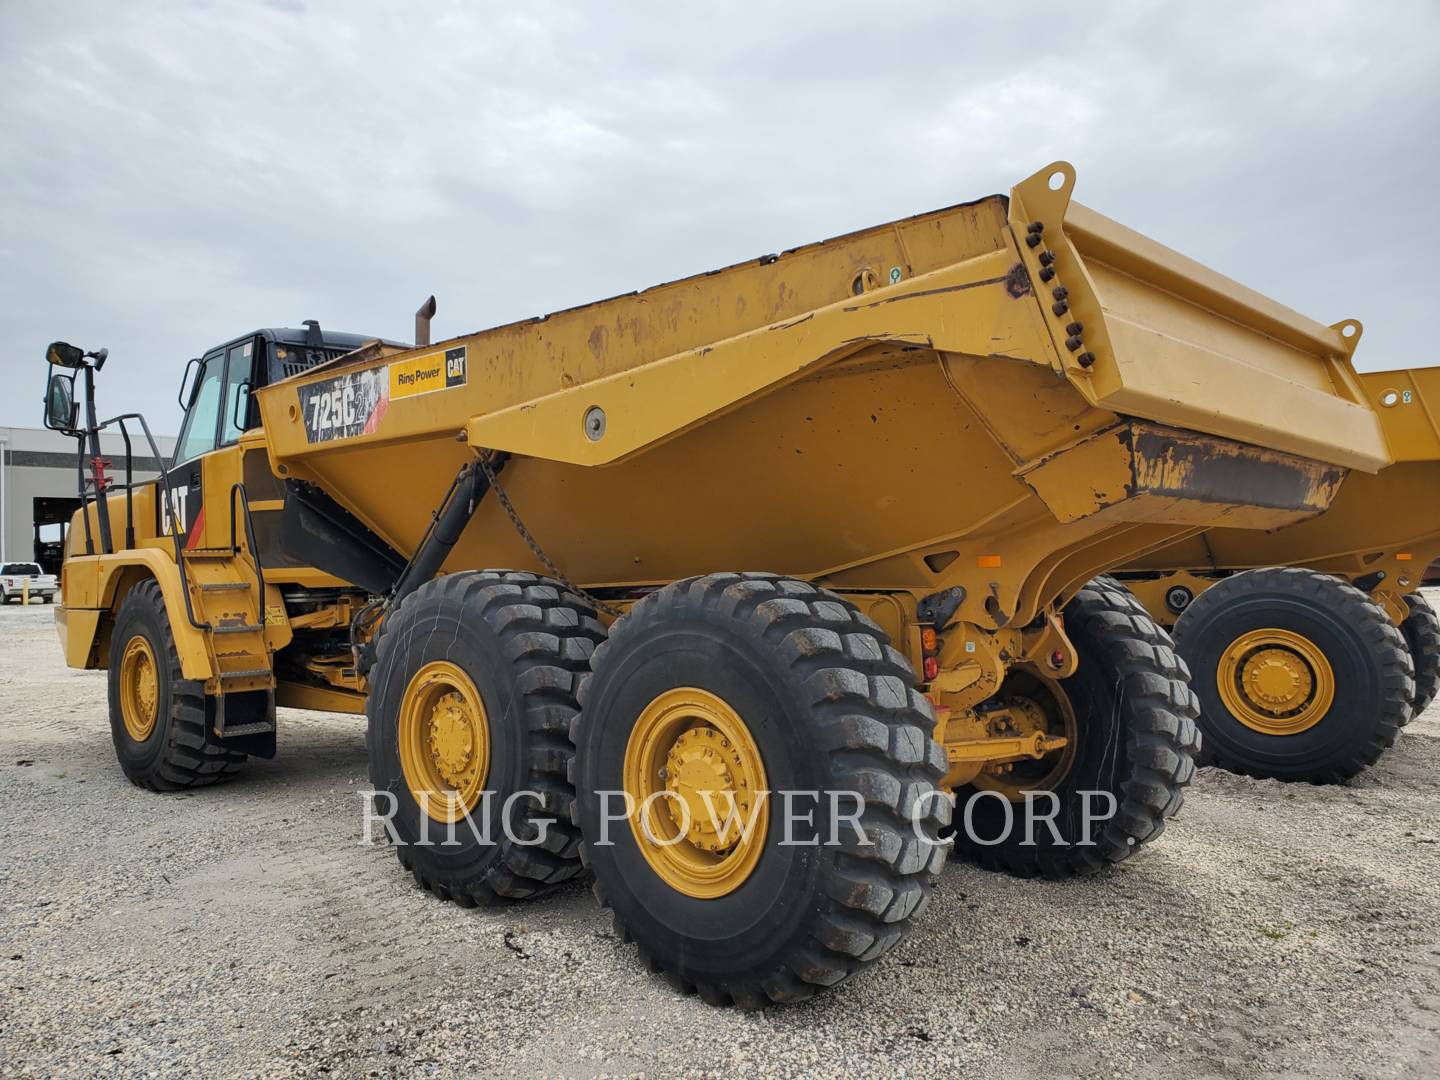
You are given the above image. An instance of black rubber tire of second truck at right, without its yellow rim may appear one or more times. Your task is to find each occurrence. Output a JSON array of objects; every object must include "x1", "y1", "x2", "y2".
[{"x1": 1175, "y1": 566, "x2": 1416, "y2": 783}]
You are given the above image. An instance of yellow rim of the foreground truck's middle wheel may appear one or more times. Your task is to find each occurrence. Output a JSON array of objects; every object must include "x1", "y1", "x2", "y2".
[{"x1": 399, "y1": 660, "x2": 490, "y2": 824}]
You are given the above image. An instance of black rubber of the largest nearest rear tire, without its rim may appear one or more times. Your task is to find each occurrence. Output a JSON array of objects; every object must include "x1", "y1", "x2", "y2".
[{"x1": 575, "y1": 573, "x2": 950, "y2": 1008}]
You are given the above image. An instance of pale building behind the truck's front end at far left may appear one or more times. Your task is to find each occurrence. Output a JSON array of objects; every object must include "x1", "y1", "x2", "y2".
[{"x1": 0, "y1": 428, "x2": 176, "y2": 572}]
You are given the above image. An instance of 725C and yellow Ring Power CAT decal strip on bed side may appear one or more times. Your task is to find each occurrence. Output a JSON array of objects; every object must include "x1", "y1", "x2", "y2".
[{"x1": 297, "y1": 346, "x2": 468, "y2": 442}]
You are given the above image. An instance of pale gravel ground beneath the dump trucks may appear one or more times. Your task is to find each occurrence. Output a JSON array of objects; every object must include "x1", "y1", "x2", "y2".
[{"x1": 0, "y1": 596, "x2": 1440, "y2": 1077}]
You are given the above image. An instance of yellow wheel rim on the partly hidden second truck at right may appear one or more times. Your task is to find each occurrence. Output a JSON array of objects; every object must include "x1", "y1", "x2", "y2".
[{"x1": 1215, "y1": 628, "x2": 1335, "y2": 736}]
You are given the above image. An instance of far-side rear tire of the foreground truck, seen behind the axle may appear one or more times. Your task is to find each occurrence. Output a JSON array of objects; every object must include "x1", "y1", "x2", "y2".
[{"x1": 955, "y1": 577, "x2": 1200, "y2": 878}]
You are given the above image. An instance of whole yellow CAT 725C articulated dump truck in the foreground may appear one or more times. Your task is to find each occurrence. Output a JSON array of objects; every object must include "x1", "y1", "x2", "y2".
[{"x1": 48, "y1": 163, "x2": 1390, "y2": 1007}]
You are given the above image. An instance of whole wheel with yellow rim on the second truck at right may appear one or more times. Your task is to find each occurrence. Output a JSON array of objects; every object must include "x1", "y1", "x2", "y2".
[{"x1": 1175, "y1": 567, "x2": 1416, "y2": 783}]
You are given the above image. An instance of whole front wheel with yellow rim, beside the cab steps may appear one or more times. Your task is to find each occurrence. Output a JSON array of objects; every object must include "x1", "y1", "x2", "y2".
[{"x1": 108, "y1": 582, "x2": 245, "y2": 792}]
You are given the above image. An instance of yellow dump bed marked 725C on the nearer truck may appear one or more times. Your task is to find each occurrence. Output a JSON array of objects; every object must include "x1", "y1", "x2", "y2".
[{"x1": 259, "y1": 163, "x2": 1388, "y2": 630}]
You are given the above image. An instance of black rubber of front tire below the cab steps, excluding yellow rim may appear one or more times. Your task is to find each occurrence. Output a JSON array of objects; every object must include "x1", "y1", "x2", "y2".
[{"x1": 108, "y1": 580, "x2": 245, "y2": 792}]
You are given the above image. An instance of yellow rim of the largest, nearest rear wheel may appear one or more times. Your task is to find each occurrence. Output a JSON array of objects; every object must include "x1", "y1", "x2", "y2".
[{"x1": 624, "y1": 687, "x2": 770, "y2": 900}]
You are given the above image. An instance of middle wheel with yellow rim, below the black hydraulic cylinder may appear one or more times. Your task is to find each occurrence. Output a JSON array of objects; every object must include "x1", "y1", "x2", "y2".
[{"x1": 366, "y1": 570, "x2": 605, "y2": 907}]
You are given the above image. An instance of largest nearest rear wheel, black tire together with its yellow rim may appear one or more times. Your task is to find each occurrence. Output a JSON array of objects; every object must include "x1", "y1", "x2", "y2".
[{"x1": 575, "y1": 573, "x2": 949, "y2": 1008}]
